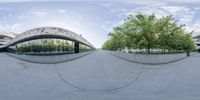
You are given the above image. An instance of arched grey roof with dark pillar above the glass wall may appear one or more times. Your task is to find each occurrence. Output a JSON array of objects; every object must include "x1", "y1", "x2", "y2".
[{"x1": 0, "y1": 27, "x2": 95, "y2": 53}]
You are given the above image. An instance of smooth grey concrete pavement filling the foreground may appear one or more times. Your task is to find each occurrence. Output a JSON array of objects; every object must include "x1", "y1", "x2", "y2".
[{"x1": 0, "y1": 51, "x2": 200, "y2": 100}]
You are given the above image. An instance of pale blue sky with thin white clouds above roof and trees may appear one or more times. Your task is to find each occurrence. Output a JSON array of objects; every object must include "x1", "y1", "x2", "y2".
[{"x1": 0, "y1": 0, "x2": 200, "y2": 48}]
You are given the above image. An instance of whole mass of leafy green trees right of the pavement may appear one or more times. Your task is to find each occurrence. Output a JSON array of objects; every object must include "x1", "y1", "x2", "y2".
[{"x1": 102, "y1": 13, "x2": 195, "y2": 53}]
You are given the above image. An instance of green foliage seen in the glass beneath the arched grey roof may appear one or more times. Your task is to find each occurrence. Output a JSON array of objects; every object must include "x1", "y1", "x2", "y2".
[{"x1": 16, "y1": 39, "x2": 92, "y2": 53}]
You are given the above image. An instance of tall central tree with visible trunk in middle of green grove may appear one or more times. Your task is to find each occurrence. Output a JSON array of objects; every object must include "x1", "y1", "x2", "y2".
[{"x1": 127, "y1": 13, "x2": 157, "y2": 53}]
